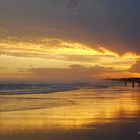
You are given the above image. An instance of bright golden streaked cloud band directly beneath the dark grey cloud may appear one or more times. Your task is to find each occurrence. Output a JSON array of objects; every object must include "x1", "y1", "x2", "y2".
[{"x1": 0, "y1": 37, "x2": 140, "y2": 70}]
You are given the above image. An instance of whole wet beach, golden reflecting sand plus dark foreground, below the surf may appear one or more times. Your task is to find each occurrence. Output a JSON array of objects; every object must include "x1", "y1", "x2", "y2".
[{"x1": 0, "y1": 87, "x2": 140, "y2": 140}]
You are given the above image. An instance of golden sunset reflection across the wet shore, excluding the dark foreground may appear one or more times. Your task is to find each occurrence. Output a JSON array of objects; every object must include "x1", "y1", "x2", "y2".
[{"x1": 0, "y1": 89, "x2": 140, "y2": 134}]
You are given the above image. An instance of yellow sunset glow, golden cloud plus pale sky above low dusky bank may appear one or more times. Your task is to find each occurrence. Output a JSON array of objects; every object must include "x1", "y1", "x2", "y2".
[{"x1": 0, "y1": 38, "x2": 140, "y2": 81}]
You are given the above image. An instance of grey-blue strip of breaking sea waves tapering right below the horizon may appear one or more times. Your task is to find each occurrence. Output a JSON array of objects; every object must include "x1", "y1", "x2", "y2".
[{"x1": 0, "y1": 83, "x2": 89, "y2": 94}]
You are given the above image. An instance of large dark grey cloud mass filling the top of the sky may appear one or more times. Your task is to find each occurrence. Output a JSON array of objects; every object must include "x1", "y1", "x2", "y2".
[{"x1": 0, "y1": 0, "x2": 140, "y2": 53}]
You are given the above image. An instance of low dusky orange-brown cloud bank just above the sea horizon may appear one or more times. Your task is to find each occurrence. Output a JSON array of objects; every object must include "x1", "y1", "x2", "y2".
[{"x1": 29, "y1": 65, "x2": 115, "y2": 82}]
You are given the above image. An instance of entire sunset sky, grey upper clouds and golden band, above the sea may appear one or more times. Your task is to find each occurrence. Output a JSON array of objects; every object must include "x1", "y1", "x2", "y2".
[{"x1": 0, "y1": 0, "x2": 140, "y2": 82}]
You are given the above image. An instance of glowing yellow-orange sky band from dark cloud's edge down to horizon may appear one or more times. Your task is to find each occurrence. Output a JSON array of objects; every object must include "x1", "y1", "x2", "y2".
[{"x1": 0, "y1": 37, "x2": 140, "y2": 81}]
